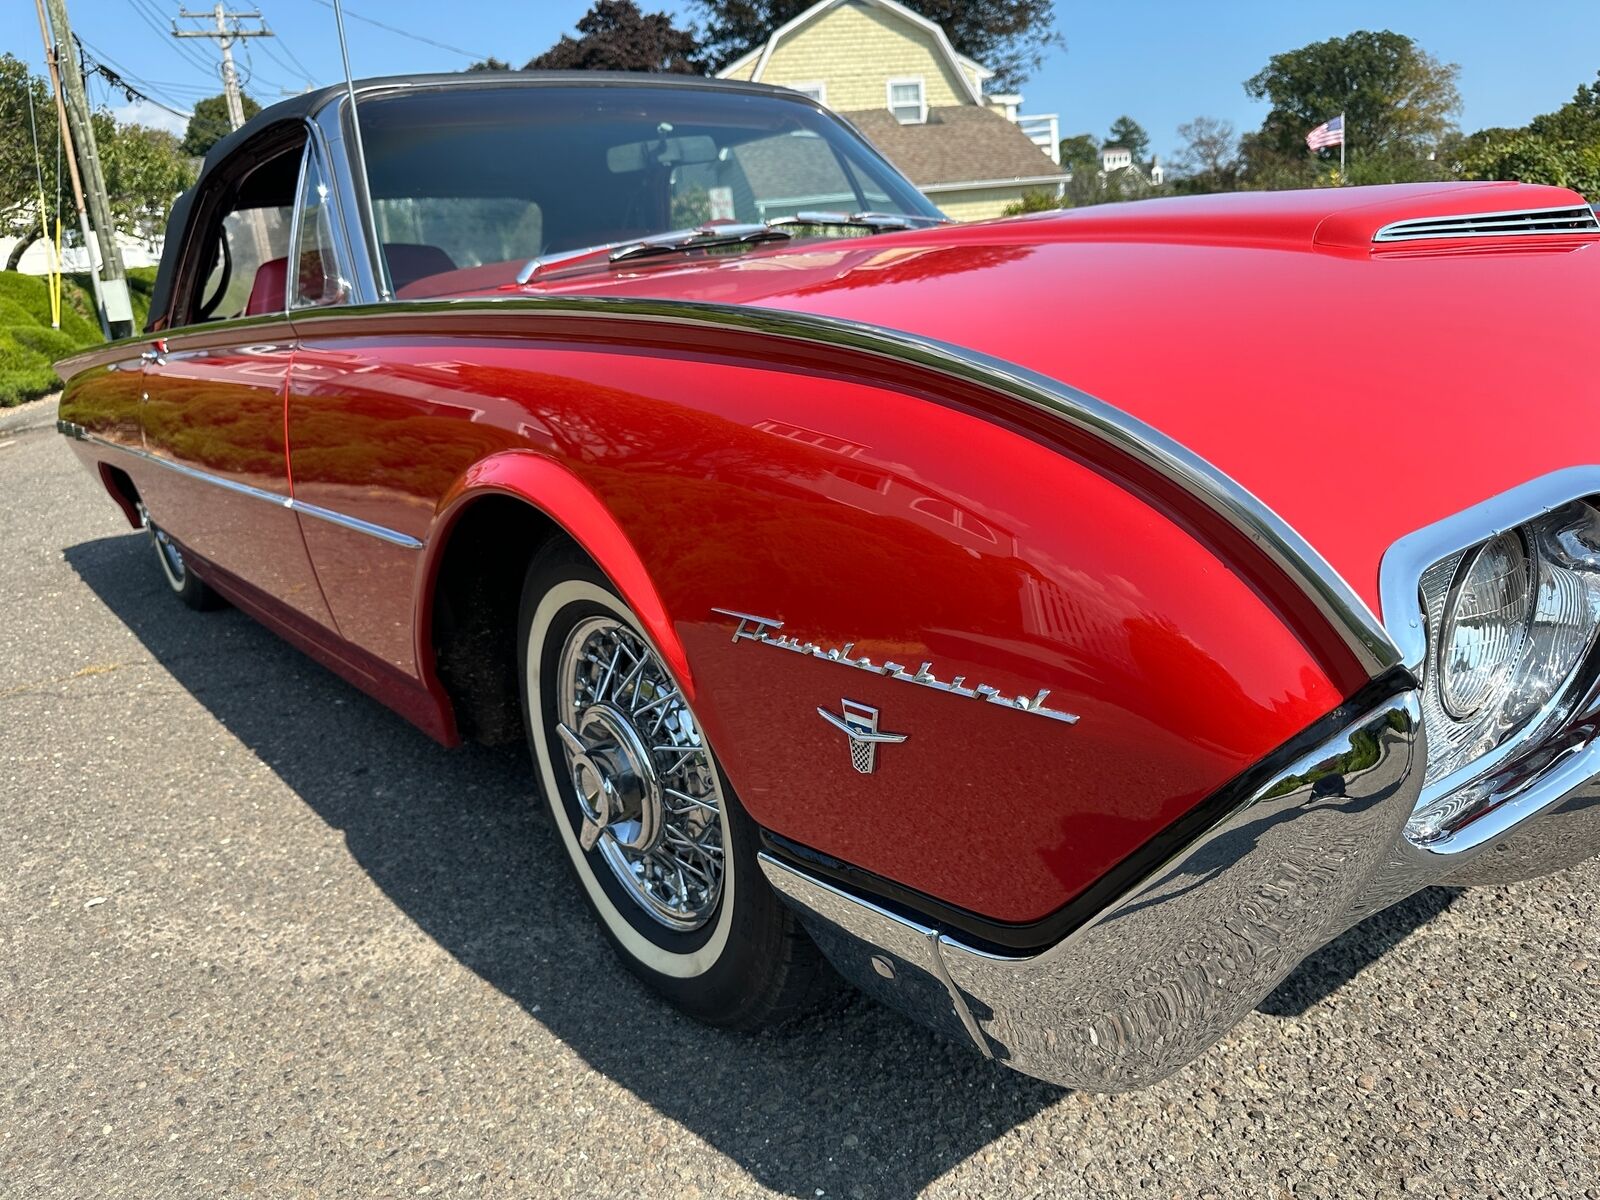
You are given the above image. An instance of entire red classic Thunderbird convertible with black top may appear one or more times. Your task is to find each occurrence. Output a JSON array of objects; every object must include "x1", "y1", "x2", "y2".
[{"x1": 59, "y1": 75, "x2": 1600, "y2": 1090}]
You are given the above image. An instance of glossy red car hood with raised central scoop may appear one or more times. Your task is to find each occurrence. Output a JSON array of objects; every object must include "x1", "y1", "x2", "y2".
[{"x1": 499, "y1": 184, "x2": 1600, "y2": 624}]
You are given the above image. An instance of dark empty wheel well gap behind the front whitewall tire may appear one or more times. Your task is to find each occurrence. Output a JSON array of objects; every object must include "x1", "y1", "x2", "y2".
[{"x1": 429, "y1": 496, "x2": 566, "y2": 746}]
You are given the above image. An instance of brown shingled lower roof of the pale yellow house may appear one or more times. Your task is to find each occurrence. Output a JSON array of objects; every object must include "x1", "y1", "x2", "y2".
[{"x1": 840, "y1": 104, "x2": 1067, "y2": 187}]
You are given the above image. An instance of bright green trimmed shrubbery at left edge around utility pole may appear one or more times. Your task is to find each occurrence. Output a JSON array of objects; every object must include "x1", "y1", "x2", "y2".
[{"x1": 0, "y1": 267, "x2": 155, "y2": 408}]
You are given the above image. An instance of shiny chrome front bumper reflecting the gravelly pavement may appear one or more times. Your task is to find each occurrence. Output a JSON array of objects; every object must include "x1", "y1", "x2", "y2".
[{"x1": 762, "y1": 691, "x2": 1600, "y2": 1091}]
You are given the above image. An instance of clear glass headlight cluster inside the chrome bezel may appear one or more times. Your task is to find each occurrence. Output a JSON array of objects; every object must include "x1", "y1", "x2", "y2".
[{"x1": 1408, "y1": 502, "x2": 1600, "y2": 840}]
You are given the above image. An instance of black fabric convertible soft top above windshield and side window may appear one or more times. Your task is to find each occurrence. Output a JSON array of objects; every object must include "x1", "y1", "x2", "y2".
[{"x1": 146, "y1": 70, "x2": 794, "y2": 330}]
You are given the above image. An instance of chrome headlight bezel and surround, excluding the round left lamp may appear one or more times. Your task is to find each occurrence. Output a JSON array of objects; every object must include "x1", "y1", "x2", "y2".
[{"x1": 1381, "y1": 467, "x2": 1600, "y2": 843}]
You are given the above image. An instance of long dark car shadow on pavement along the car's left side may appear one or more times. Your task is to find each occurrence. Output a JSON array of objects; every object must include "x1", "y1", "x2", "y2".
[{"x1": 66, "y1": 534, "x2": 1067, "y2": 1197}]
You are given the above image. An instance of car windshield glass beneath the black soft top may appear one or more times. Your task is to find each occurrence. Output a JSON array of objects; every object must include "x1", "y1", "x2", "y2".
[{"x1": 360, "y1": 85, "x2": 941, "y2": 294}]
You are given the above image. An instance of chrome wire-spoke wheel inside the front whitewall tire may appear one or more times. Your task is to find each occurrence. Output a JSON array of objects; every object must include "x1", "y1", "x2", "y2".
[{"x1": 555, "y1": 616, "x2": 723, "y2": 933}]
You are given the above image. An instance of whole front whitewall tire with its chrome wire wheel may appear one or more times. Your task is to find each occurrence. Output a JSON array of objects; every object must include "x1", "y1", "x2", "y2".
[{"x1": 518, "y1": 542, "x2": 829, "y2": 1027}]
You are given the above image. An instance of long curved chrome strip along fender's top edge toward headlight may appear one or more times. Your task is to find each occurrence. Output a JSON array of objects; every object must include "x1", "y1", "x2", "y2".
[{"x1": 281, "y1": 296, "x2": 1400, "y2": 677}]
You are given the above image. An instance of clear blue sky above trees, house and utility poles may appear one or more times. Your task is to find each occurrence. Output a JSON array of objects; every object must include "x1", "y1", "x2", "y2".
[{"x1": 0, "y1": 0, "x2": 1600, "y2": 154}]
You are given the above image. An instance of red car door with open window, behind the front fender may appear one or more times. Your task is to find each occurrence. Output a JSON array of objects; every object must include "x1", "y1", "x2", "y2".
[{"x1": 142, "y1": 126, "x2": 333, "y2": 627}]
